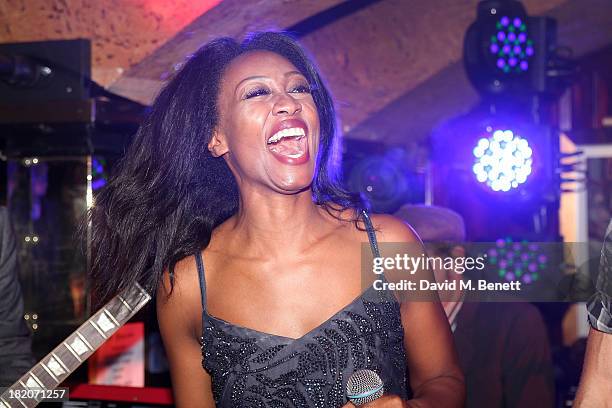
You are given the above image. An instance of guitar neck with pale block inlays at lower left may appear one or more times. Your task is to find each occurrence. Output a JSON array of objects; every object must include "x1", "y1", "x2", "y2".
[{"x1": 0, "y1": 283, "x2": 151, "y2": 408}]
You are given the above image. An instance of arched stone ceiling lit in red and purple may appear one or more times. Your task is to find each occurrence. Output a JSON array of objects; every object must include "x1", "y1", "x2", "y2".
[{"x1": 0, "y1": 0, "x2": 612, "y2": 147}]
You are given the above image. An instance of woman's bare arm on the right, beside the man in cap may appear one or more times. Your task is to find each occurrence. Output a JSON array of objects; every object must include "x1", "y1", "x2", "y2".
[{"x1": 366, "y1": 215, "x2": 465, "y2": 408}]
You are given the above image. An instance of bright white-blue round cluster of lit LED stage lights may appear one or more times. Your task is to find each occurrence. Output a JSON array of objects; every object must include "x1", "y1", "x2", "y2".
[{"x1": 472, "y1": 130, "x2": 533, "y2": 191}]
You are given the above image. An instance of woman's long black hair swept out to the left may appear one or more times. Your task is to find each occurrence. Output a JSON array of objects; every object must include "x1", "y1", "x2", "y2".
[{"x1": 89, "y1": 32, "x2": 364, "y2": 304}]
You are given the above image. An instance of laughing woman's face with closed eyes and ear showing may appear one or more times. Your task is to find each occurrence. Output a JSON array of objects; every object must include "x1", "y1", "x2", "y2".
[{"x1": 208, "y1": 51, "x2": 319, "y2": 194}]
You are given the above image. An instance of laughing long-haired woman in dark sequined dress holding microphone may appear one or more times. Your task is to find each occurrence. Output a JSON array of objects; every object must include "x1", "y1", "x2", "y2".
[{"x1": 92, "y1": 33, "x2": 463, "y2": 407}]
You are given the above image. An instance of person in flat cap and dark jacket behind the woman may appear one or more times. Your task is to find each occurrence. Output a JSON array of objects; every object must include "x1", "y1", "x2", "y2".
[{"x1": 395, "y1": 205, "x2": 554, "y2": 408}]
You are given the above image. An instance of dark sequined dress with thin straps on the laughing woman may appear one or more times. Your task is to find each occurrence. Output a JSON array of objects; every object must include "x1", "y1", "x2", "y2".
[{"x1": 196, "y1": 212, "x2": 407, "y2": 408}]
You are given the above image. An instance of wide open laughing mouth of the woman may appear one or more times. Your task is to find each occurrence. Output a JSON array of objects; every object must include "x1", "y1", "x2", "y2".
[{"x1": 267, "y1": 122, "x2": 309, "y2": 164}]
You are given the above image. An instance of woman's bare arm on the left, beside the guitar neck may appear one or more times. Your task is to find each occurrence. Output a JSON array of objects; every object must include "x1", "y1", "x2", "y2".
[{"x1": 156, "y1": 263, "x2": 215, "y2": 408}]
